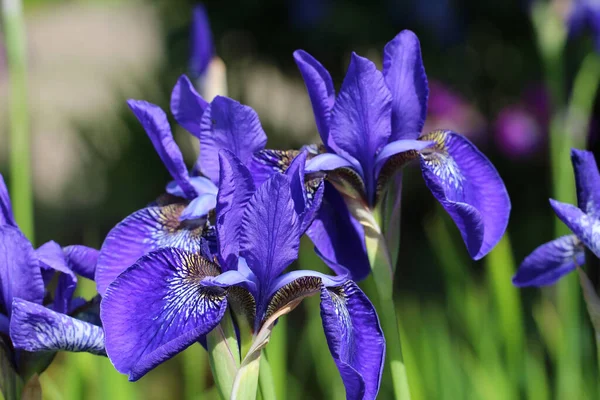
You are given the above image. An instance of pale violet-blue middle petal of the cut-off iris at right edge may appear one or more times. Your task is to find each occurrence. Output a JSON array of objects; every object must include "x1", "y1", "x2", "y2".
[{"x1": 550, "y1": 199, "x2": 600, "y2": 257}]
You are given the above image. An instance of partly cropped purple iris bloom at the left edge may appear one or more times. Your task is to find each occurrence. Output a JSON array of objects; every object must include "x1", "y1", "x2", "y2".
[{"x1": 0, "y1": 176, "x2": 105, "y2": 372}]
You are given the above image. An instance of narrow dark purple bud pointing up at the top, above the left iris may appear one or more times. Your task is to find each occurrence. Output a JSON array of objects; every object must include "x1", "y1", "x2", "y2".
[{"x1": 190, "y1": 4, "x2": 215, "y2": 77}]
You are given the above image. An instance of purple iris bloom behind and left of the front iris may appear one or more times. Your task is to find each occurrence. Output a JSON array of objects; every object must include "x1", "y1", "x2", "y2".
[{"x1": 96, "y1": 76, "x2": 267, "y2": 295}]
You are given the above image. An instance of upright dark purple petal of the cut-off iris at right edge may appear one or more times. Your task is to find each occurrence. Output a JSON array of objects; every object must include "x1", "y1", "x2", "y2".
[{"x1": 571, "y1": 149, "x2": 600, "y2": 218}]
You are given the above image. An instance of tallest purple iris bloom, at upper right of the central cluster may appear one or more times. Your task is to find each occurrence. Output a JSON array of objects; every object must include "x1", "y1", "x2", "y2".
[{"x1": 294, "y1": 31, "x2": 510, "y2": 279}]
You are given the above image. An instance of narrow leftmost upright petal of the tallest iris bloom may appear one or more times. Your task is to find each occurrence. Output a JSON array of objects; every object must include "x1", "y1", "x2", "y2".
[{"x1": 294, "y1": 50, "x2": 335, "y2": 147}]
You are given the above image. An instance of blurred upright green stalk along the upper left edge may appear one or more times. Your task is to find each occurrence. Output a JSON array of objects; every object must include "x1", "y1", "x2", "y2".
[{"x1": 2, "y1": 0, "x2": 34, "y2": 242}]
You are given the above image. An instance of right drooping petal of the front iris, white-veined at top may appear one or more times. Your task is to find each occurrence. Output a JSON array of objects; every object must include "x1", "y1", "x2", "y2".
[{"x1": 321, "y1": 281, "x2": 385, "y2": 400}]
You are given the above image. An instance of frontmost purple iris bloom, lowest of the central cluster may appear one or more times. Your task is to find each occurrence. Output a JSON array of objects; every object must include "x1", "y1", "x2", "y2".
[{"x1": 101, "y1": 150, "x2": 385, "y2": 399}]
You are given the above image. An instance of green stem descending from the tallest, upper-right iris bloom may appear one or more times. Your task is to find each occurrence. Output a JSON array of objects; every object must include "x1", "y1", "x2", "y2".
[{"x1": 363, "y1": 210, "x2": 410, "y2": 400}]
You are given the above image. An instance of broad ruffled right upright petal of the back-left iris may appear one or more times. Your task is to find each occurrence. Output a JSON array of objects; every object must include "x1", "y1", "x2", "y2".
[{"x1": 198, "y1": 96, "x2": 267, "y2": 183}]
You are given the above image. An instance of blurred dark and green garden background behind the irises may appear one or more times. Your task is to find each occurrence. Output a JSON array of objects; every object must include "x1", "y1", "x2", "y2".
[{"x1": 0, "y1": 0, "x2": 600, "y2": 400}]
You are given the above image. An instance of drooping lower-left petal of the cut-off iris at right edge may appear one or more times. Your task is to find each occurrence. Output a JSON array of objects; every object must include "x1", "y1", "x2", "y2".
[{"x1": 512, "y1": 235, "x2": 585, "y2": 287}]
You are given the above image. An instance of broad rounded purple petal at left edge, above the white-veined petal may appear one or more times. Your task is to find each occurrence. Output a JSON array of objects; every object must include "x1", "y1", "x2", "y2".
[{"x1": 0, "y1": 225, "x2": 44, "y2": 318}]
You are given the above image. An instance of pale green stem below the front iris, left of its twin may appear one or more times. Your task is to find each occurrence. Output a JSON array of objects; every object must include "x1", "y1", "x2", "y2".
[{"x1": 207, "y1": 310, "x2": 240, "y2": 400}]
